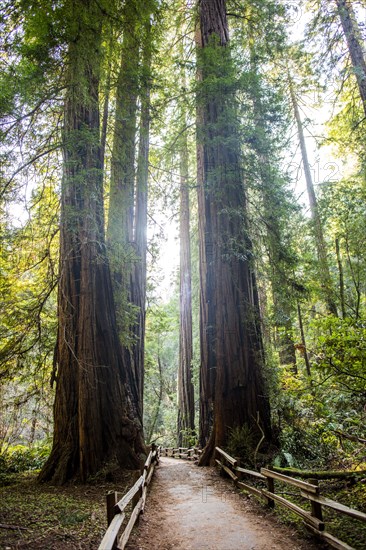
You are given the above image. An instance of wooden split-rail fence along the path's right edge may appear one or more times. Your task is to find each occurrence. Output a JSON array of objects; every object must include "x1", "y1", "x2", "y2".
[{"x1": 215, "y1": 447, "x2": 366, "y2": 550}]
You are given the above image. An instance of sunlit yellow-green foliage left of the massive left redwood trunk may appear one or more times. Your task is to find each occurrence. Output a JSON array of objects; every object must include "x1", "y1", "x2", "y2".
[{"x1": 0, "y1": 185, "x2": 58, "y2": 448}]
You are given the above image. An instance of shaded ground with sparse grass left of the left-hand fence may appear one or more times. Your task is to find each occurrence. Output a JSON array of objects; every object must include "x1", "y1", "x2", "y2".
[{"x1": 0, "y1": 471, "x2": 133, "y2": 550}]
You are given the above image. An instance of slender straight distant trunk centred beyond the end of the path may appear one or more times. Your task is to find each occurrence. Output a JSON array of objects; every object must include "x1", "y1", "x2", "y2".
[{"x1": 178, "y1": 89, "x2": 194, "y2": 446}]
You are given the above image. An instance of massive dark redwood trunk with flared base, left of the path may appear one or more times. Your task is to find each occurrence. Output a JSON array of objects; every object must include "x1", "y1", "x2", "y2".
[{"x1": 40, "y1": 0, "x2": 139, "y2": 483}]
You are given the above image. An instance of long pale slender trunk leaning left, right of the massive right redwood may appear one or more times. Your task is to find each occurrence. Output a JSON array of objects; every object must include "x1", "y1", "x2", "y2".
[{"x1": 288, "y1": 78, "x2": 338, "y2": 316}]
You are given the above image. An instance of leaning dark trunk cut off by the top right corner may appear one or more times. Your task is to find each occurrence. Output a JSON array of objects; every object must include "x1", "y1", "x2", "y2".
[{"x1": 336, "y1": 0, "x2": 366, "y2": 116}]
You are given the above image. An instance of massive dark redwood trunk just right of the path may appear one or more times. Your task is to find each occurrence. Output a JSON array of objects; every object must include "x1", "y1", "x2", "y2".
[{"x1": 197, "y1": 0, "x2": 271, "y2": 464}]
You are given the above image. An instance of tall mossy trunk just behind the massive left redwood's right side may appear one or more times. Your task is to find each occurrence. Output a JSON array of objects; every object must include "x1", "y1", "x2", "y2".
[{"x1": 107, "y1": 2, "x2": 142, "y2": 424}]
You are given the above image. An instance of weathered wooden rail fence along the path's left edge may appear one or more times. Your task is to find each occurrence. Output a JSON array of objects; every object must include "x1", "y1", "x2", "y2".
[{"x1": 98, "y1": 449, "x2": 160, "y2": 550}]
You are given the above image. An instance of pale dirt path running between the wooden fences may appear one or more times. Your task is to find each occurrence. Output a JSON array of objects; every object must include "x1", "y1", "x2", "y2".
[{"x1": 127, "y1": 458, "x2": 319, "y2": 550}]
